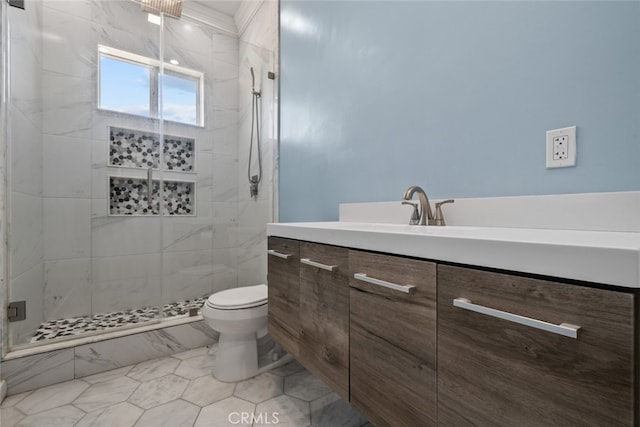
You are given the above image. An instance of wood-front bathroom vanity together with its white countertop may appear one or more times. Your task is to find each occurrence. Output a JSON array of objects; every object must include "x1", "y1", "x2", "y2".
[{"x1": 267, "y1": 222, "x2": 640, "y2": 426}]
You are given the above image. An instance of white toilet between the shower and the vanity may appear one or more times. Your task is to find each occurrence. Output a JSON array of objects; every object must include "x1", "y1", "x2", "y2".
[{"x1": 202, "y1": 285, "x2": 291, "y2": 382}]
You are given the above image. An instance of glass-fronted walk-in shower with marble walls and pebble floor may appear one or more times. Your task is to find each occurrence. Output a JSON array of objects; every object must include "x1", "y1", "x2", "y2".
[{"x1": 0, "y1": 0, "x2": 277, "y2": 350}]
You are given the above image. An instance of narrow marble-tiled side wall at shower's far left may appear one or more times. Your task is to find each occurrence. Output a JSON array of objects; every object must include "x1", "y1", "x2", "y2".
[{"x1": 8, "y1": 0, "x2": 44, "y2": 341}]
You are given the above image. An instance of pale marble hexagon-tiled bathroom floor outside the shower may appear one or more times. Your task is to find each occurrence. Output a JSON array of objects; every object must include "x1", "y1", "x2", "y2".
[{"x1": 0, "y1": 345, "x2": 370, "y2": 427}]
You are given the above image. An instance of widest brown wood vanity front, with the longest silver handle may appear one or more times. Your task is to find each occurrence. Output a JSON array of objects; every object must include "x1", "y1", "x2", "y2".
[{"x1": 438, "y1": 265, "x2": 637, "y2": 427}]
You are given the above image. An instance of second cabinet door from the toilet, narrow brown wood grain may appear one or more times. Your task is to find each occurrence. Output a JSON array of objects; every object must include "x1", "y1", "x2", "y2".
[{"x1": 299, "y1": 242, "x2": 349, "y2": 400}]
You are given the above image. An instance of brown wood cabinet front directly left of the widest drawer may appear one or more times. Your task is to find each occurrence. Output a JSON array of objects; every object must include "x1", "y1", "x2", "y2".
[{"x1": 349, "y1": 251, "x2": 436, "y2": 427}]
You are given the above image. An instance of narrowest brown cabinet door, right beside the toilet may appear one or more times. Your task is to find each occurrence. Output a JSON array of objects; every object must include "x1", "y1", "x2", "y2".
[{"x1": 267, "y1": 237, "x2": 300, "y2": 358}]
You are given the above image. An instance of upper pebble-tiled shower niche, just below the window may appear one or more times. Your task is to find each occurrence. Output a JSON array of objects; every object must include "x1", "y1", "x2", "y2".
[{"x1": 109, "y1": 126, "x2": 195, "y2": 172}]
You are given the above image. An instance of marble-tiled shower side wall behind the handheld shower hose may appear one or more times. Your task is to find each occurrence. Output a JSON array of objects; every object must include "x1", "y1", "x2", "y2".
[{"x1": 238, "y1": 1, "x2": 279, "y2": 284}]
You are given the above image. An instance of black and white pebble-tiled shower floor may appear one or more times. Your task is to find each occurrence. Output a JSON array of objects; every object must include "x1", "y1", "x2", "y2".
[{"x1": 31, "y1": 297, "x2": 206, "y2": 342}]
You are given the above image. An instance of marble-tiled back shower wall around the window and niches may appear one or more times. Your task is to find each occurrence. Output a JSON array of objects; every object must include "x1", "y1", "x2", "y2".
[{"x1": 23, "y1": 0, "x2": 238, "y2": 341}]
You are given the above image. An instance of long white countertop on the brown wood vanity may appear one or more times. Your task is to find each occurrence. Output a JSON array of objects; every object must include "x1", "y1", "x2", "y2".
[{"x1": 267, "y1": 222, "x2": 640, "y2": 288}]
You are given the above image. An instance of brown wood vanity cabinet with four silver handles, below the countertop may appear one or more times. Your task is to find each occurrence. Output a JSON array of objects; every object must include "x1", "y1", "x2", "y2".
[{"x1": 268, "y1": 237, "x2": 640, "y2": 427}]
